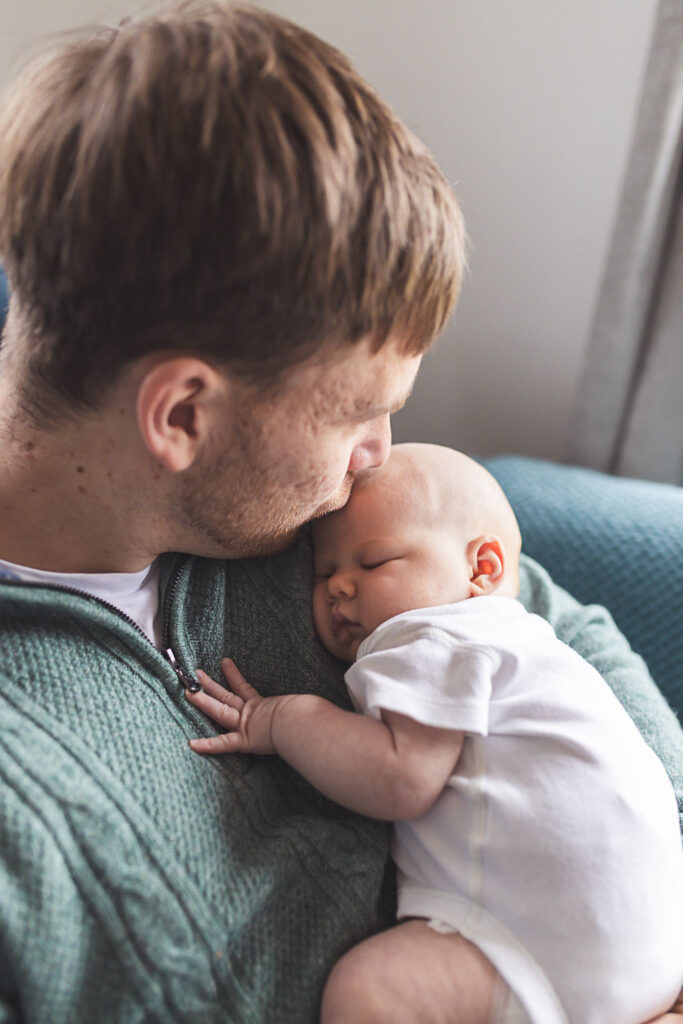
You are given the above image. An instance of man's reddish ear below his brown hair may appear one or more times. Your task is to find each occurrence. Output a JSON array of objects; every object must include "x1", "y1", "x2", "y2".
[{"x1": 136, "y1": 356, "x2": 229, "y2": 473}]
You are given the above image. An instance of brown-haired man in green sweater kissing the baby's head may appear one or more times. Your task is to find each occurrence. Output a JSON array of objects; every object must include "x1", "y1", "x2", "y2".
[{"x1": 0, "y1": 3, "x2": 679, "y2": 1024}]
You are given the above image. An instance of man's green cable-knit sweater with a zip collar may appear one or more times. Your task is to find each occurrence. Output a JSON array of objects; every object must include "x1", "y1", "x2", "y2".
[{"x1": 0, "y1": 537, "x2": 683, "y2": 1024}]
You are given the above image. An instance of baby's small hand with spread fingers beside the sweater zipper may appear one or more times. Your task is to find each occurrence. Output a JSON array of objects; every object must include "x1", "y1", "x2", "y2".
[{"x1": 185, "y1": 657, "x2": 283, "y2": 754}]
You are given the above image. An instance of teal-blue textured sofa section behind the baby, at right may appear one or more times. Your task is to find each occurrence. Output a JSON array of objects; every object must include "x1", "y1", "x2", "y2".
[{"x1": 484, "y1": 456, "x2": 683, "y2": 720}]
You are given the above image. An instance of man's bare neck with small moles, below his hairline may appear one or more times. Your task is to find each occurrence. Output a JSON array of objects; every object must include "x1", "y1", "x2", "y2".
[{"x1": 0, "y1": 381, "x2": 163, "y2": 572}]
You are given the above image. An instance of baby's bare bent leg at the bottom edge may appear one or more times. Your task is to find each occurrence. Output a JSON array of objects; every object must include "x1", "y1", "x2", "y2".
[{"x1": 321, "y1": 920, "x2": 507, "y2": 1024}]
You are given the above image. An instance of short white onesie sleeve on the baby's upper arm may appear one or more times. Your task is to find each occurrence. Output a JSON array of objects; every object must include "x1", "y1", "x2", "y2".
[{"x1": 344, "y1": 617, "x2": 498, "y2": 736}]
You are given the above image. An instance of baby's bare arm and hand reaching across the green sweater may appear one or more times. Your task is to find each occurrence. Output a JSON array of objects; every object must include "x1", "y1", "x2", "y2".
[{"x1": 185, "y1": 658, "x2": 463, "y2": 821}]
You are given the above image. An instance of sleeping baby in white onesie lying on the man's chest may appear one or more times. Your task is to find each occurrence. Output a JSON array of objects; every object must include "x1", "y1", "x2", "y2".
[{"x1": 187, "y1": 444, "x2": 683, "y2": 1024}]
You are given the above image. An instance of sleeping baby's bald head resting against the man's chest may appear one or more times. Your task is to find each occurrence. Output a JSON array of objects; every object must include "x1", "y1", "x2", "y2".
[{"x1": 312, "y1": 444, "x2": 521, "y2": 662}]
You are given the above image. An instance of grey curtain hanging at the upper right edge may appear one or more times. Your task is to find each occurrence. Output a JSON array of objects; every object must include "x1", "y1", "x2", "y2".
[{"x1": 566, "y1": 0, "x2": 683, "y2": 484}]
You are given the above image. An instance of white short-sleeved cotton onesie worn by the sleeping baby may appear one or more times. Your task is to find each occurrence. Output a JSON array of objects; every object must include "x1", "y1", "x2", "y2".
[{"x1": 346, "y1": 597, "x2": 683, "y2": 1024}]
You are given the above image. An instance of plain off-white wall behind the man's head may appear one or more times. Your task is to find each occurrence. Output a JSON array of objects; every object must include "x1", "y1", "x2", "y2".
[{"x1": 0, "y1": 0, "x2": 655, "y2": 458}]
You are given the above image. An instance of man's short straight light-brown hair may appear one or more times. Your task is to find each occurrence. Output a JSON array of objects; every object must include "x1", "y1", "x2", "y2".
[{"x1": 0, "y1": 2, "x2": 465, "y2": 419}]
